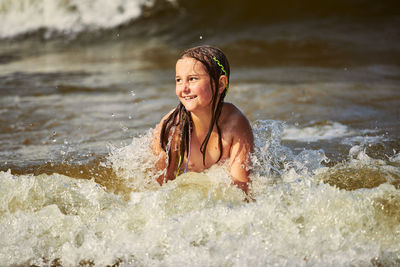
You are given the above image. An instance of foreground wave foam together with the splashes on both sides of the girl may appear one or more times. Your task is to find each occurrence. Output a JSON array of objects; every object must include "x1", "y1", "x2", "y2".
[{"x1": 0, "y1": 124, "x2": 400, "y2": 266}]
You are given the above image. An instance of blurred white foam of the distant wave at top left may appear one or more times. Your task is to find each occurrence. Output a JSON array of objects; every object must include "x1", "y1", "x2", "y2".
[{"x1": 0, "y1": 0, "x2": 155, "y2": 38}]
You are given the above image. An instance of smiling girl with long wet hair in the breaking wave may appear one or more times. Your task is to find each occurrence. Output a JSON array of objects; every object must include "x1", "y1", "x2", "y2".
[{"x1": 152, "y1": 46, "x2": 253, "y2": 193}]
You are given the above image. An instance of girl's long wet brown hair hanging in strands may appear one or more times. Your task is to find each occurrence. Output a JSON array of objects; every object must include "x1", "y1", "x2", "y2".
[{"x1": 160, "y1": 46, "x2": 230, "y2": 173}]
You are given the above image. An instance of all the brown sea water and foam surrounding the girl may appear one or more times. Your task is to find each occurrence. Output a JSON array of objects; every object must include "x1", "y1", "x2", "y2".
[{"x1": 0, "y1": 0, "x2": 400, "y2": 266}]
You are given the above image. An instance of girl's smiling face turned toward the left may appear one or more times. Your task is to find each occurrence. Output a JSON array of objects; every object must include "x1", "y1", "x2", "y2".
[{"x1": 175, "y1": 57, "x2": 213, "y2": 112}]
